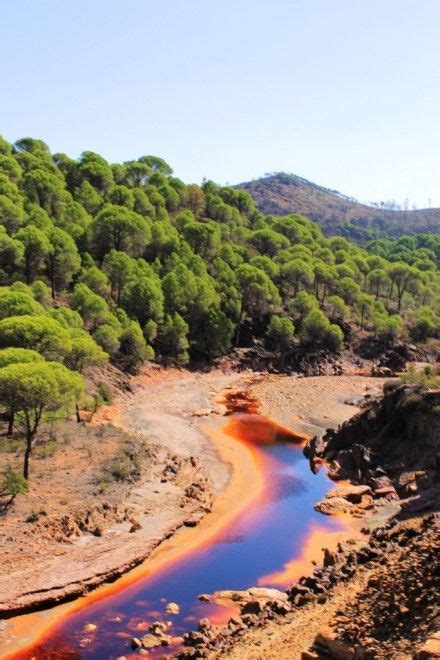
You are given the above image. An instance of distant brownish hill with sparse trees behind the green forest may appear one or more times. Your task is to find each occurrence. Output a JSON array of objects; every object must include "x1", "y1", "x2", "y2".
[{"x1": 237, "y1": 172, "x2": 440, "y2": 238}]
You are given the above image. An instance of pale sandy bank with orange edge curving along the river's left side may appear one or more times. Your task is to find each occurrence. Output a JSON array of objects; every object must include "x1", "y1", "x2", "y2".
[{"x1": 0, "y1": 372, "x2": 380, "y2": 650}]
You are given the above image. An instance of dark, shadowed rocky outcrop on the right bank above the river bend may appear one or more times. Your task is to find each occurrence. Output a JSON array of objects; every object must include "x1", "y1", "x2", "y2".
[{"x1": 304, "y1": 384, "x2": 440, "y2": 513}]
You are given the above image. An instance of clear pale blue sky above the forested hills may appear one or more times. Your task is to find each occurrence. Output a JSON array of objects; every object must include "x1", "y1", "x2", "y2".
[{"x1": 0, "y1": 0, "x2": 440, "y2": 206}]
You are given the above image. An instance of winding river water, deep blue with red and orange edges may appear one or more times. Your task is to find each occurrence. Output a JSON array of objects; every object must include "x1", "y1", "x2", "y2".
[{"x1": 9, "y1": 402, "x2": 342, "y2": 660}]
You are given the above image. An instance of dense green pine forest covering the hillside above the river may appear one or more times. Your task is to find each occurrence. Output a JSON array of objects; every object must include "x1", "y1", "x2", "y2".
[{"x1": 0, "y1": 138, "x2": 440, "y2": 484}]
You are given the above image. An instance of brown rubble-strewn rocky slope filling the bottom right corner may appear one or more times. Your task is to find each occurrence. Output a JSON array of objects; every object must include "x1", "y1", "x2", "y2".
[{"x1": 176, "y1": 514, "x2": 440, "y2": 660}]
